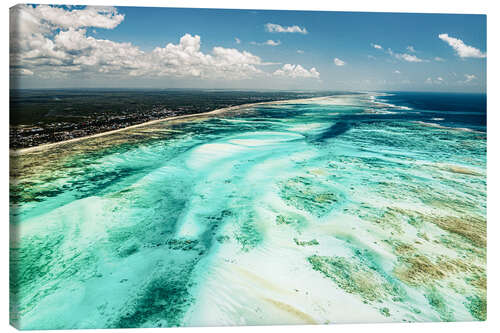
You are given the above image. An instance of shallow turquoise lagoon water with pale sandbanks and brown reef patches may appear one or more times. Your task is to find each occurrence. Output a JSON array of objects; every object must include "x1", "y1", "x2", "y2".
[{"x1": 10, "y1": 94, "x2": 486, "y2": 329}]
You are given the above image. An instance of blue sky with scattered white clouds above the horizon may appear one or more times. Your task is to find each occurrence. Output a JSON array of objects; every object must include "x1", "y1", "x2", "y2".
[{"x1": 10, "y1": 5, "x2": 487, "y2": 92}]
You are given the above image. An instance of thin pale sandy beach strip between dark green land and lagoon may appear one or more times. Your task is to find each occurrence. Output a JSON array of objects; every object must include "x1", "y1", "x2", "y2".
[{"x1": 9, "y1": 95, "x2": 336, "y2": 156}]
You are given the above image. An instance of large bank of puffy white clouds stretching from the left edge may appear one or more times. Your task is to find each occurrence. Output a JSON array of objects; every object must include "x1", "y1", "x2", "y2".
[{"x1": 10, "y1": 5, "x2": 294, "y2": 80}]
